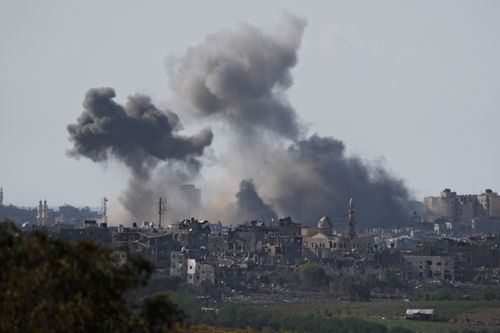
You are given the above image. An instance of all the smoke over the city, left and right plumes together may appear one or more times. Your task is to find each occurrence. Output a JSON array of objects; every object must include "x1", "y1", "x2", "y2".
[{"x1": 68, "y1": 15, "x2": 410, "y2": 226}]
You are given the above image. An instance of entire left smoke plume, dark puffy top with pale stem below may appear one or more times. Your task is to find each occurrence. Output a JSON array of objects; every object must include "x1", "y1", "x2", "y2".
[{"x1": 68, "y1": 88, "x2": 213, "y2": 224}]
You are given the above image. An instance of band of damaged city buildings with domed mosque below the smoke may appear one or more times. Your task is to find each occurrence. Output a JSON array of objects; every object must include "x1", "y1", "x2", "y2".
[{"x1": 0, "y1": 186, "x2": 500, "y2": 300}]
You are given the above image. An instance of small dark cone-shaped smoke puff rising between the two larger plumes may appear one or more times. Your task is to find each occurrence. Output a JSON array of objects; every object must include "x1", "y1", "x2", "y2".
[{"x1": 236, "y1": 179, "x2": 276, "y2": 221}]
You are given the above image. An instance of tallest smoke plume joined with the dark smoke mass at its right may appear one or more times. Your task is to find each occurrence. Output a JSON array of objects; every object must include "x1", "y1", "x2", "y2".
[{"x1": 170, "y1": 15, "x2": 410, "y2": 226}]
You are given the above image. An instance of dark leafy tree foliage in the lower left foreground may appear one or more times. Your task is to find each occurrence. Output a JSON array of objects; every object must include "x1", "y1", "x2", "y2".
[{"x1": 0, "y1": 222, "x2": 184, "y2": 333}]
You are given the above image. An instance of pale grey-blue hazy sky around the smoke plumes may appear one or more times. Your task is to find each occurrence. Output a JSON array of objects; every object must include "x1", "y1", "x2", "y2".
[{"x1": 0, "y1": 0, "x2": 500, "y2": 206}]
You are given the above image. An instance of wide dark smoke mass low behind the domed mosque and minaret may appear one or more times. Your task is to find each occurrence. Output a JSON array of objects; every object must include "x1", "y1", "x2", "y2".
[{"x1": 270, "y1": 135, "x2": 410, "y2": 226}]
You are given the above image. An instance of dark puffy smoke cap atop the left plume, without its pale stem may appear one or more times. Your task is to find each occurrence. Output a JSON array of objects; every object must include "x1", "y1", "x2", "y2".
[{"x1": 68, "y1": 88, "x2": 213, "y2": 177}]
